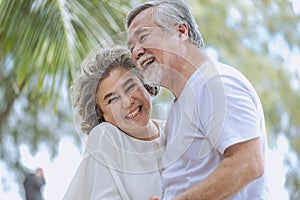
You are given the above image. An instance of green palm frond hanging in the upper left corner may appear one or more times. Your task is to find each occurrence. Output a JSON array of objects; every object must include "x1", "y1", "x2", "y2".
[{"x1": 0, "y1": 0, "x2": 129, "y2": 108}]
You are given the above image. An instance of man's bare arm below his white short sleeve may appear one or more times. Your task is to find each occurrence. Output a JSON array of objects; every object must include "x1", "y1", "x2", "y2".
[{"x1": 174, "y1": 138, "x2": 264, "y2": 200}]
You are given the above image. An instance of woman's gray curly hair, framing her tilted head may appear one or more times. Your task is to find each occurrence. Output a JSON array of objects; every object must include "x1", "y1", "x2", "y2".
[{"x1": 71, "y1": 46, "x2": 159, "y2": 134}]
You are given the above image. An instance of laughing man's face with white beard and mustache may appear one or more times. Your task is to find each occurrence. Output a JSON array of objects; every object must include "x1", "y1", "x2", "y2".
[{"x1": 128, "y1": 8, "x2": 178, "y2": 85}]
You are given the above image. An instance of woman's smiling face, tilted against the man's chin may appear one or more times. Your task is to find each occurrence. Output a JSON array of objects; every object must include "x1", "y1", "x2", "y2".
[{"x1": 96, "y1": 67, "x2": 151, "y2": 138}]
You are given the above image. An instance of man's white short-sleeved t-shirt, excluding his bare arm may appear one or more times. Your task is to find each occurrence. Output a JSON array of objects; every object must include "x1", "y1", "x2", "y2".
[{"x1": 162, "y1": 62, "x2": 268, "y2": 200}]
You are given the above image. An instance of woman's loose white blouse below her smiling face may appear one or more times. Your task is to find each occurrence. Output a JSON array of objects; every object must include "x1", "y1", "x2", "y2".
[{"x1": 64, "y1": 120, "x2": 165, "y2": 200}]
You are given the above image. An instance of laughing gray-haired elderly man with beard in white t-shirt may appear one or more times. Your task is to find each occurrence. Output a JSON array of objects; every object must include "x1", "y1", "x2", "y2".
[{"x1": 126, "y1": 0, "x2": 268, "y2": 200}]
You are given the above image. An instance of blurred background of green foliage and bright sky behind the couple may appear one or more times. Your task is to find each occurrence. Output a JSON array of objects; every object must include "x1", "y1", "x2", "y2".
[{"x1": 0, "y1": 0, "x2": 300, "y2": 200}]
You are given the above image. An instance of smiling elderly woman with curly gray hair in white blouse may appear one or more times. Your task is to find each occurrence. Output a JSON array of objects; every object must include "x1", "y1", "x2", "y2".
[{"x1": 64, "y1": 47, "x2": 164, "y2": 200}]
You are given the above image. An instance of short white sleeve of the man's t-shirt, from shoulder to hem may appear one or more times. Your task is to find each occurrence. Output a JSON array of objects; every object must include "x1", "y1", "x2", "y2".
[{"x1": 198, "y1": 63, "x2": 260, "y2": 154}]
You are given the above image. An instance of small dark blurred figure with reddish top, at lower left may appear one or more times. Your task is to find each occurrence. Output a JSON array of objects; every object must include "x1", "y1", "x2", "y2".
[{"x1": 23, "y1": 167, "x2": 46, "y2": 200}]
